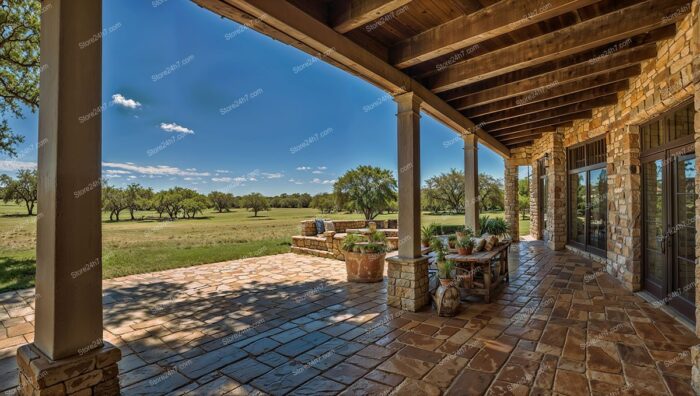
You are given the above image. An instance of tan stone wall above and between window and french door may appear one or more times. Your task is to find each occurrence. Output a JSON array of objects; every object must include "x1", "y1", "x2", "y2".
[{"x1": 548, "y1": 10, "x2": 700, "y2": 290}]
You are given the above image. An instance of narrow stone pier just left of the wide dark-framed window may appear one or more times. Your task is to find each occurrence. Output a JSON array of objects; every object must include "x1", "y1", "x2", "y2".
[{"x1": 545, "y1": 128, "x2": 567, "y2": 250}]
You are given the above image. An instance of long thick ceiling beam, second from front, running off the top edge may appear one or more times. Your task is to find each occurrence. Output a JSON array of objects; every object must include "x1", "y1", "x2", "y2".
[{"x1": 389, "y1": 0, "x2": 600, "y2": 69}]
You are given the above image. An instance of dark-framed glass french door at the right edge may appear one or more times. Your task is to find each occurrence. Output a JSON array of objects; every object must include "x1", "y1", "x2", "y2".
[{"x1": 642, "y1": 144, "x2": 697, "y2": 321}]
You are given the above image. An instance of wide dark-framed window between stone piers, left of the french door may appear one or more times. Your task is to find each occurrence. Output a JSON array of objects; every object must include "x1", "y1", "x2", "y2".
[{"x1": 568, "y1": 139, "x2": 608, "y2": 256}]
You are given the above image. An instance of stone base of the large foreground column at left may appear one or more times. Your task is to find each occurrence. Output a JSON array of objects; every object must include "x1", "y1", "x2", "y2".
[{"x1": 17, "y1": 342, "x2": 122, "y2": 396}]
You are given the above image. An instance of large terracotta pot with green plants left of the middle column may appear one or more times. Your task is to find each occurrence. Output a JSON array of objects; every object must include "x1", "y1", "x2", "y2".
[{"x1": 342, "y1": 232, "x2": 387, "y2": 283}]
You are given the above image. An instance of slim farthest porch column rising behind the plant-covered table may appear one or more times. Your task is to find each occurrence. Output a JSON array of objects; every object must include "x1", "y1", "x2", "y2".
[{"x1": 464, "y1": 134, "x2": 479, "y2": 235}]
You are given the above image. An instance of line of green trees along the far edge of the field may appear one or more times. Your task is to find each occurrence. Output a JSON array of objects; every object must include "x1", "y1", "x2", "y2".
[{"x1": 0, "y1": 166, "x2": 508, "y2": 221}]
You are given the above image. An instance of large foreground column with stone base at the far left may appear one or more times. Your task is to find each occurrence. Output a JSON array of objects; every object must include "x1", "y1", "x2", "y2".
[{"x1": 17, "y1": 0, "x2": 121, "y2": 395}]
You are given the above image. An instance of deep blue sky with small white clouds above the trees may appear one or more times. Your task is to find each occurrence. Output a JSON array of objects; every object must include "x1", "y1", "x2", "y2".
[{"x1": 0, "y1": 0, "x2": 516, "y2": 195}]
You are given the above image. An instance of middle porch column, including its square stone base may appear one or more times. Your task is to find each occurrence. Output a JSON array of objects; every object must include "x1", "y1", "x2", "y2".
[{"x1": 387, "y1": 92, "x2": 428, "y2": 311}]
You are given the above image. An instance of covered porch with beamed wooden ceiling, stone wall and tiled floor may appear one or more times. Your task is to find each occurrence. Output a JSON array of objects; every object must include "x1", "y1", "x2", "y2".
[{"x1": 20, "y1": 0, "x2": 700, "y2": 394}]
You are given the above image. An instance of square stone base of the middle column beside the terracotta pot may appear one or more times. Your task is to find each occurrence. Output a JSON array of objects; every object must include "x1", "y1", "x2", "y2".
[{"x1": 386, "y1": 257, "x2": 430, "y2": 312}]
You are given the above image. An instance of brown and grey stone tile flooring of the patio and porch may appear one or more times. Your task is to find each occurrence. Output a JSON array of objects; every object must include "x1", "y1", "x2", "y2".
[{"x1": 0, "y1": 242, "x2": 698, "y2": 395}]
